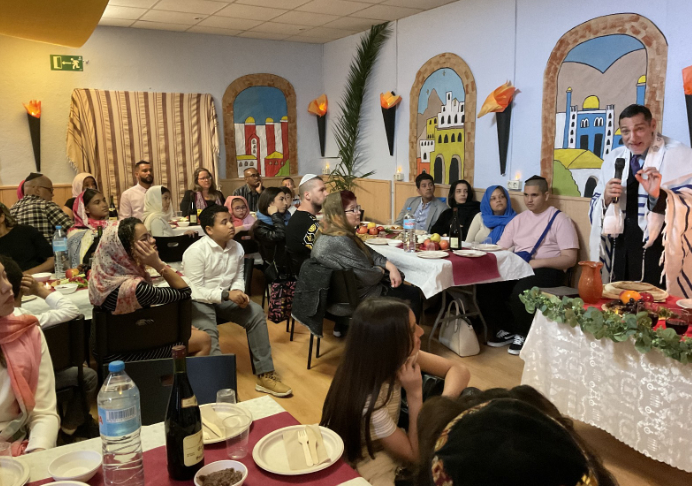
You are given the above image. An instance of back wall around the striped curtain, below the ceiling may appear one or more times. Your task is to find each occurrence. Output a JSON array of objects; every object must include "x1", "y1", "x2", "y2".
[{"x1": 0, "y1": 27, "x2": 323, "y2": 185}]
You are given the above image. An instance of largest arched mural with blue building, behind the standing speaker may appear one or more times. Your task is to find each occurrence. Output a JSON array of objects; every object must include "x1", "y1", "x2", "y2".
[{"x1": 541, "y1": 14, "x2": 667, "y2": 192}]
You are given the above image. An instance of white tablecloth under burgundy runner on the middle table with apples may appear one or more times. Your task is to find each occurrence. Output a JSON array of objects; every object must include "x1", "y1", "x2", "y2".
[{"x1": 370, "y1": 245, "x2": 533, "y2": 299}]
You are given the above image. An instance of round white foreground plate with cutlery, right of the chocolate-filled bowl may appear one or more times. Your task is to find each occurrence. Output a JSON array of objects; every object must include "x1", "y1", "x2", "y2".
[{"x1": 252, "y1": 425, "x2": 344, "y2": 476}]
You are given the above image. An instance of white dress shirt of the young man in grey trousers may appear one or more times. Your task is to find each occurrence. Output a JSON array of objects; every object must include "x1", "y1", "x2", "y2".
[{"x1": 183, "y1": 236, "x2": 245, "y2": 304}]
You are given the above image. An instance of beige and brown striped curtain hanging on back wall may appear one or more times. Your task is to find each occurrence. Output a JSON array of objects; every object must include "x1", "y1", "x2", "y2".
[{"x1": 67, "y1": 89, "x2": 219, "y2": 208}]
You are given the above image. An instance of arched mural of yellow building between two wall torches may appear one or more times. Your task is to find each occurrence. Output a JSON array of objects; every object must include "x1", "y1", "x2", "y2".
[{"x1": 409, "y1": 53, "x2": 476, "y2": 184}]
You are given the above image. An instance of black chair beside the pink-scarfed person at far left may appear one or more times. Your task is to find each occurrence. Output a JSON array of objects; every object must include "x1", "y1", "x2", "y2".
[{"x1": 43, "y1": 314, "x2": 89, "y2": 424}]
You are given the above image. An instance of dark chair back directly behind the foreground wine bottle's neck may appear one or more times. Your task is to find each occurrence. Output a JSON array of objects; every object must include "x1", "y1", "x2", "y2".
[{"x1": 116, "y1": 354, "x2": 238, "y2": 425}]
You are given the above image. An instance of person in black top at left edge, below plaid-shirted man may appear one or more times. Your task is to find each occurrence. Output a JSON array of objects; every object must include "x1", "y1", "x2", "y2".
[{"x1": 0, "y1": 203, "x2": 55, "y2": 275}]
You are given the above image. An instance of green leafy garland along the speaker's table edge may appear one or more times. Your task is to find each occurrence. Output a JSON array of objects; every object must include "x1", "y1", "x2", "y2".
[{"x1": 519, "y1": 287, "x2": 692, "y2": 364}]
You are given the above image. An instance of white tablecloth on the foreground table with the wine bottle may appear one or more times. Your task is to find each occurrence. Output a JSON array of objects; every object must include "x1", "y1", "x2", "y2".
[{"x1": 18, "y1": 396, "x2": 370, "y2": 486}]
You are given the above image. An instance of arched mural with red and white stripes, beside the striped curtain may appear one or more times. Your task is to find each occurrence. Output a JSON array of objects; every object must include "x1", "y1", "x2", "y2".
[{"x1": 223, "y1": 74, "x2": 298, "y2": 177}]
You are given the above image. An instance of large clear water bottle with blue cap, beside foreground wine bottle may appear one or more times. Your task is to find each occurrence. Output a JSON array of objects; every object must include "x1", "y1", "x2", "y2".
[{"x1": 98, "y1": 361, "x2": 144, "y2": 486}]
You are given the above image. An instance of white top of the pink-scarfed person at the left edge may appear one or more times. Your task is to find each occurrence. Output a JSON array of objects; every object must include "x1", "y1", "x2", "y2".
[{"x1": 0, "y1": 324, "x2": 60, "y2": 452}]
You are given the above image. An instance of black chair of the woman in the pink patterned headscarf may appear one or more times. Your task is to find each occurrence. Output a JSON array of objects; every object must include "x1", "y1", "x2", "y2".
[{"x1": 92, "y1": 299, "x2": 192, "y2": 382}]
